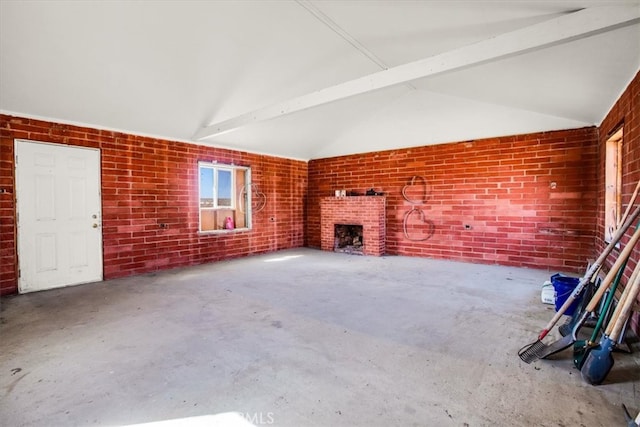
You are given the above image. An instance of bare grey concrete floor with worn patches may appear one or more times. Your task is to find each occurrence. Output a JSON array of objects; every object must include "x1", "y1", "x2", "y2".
[{"x1": 0, "y1": 249, "x2": 640, "y2": 426}]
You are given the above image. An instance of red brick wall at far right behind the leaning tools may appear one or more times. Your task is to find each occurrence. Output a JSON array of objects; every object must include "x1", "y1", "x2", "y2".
[{"x1": 596, "y1": 73, "x2": 640, "y2": 332}]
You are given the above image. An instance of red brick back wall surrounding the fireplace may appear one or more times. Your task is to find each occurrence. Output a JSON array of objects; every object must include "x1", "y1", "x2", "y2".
[{"x1": 307, "y1": 127, "x2": 598, "y2": 272}]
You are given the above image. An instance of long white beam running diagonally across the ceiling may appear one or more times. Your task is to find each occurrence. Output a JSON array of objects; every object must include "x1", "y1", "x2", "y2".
[{"x1": 193, "y1": 6, "x2": 640, "y2": 141}]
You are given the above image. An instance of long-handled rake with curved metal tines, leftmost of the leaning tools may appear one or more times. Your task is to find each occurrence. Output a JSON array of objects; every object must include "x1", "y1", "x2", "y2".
[{"x1": 518, "y1": 202, "x2": 640, "y2": 363}]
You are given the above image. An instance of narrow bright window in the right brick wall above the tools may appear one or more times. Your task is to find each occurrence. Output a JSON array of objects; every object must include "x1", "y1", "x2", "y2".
[{"x1": 604, "y1": 128, "x2": 622, "y2": 243}]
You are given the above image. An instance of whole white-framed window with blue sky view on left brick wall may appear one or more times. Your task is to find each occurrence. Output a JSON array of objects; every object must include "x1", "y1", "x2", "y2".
[{"x1": 198, "y1": 162, "x2": 251, "y2": 231}]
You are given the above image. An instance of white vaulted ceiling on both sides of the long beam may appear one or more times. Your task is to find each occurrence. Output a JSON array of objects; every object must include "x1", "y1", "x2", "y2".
[{"x1": 0, "y1": 0, "x2": 640, "y2": 160}]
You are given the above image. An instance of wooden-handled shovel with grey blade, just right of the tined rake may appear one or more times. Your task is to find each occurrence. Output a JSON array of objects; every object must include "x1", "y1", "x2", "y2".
[{"x1": 520, "y1": 224, "x2": 640, "y2": 363}]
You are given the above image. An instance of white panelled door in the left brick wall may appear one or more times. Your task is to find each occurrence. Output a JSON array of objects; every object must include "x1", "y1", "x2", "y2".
[{"x1": 15, "y1": 140, "x2": 102, "y2": 293}]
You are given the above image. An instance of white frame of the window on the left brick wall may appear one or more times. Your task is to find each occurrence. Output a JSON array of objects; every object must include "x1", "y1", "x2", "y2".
[{"x1": 198, "y1": 161, "x2": 252, "y2": 234}]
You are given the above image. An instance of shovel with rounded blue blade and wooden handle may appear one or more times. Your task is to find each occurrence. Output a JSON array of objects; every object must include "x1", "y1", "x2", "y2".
[{"x1": 580, "y1": 263, "x2": 640, "y2": 385}]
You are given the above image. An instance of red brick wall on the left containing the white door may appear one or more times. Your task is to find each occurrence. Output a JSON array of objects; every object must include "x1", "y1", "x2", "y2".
[{"x1": 0, "y1": 115, "x2": 307, "y2": 294}]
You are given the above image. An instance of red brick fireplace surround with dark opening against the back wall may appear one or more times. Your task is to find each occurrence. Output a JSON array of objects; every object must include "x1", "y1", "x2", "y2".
[{"x1": 320, "y1": 196, "x2": 386, "y2": 256}]
